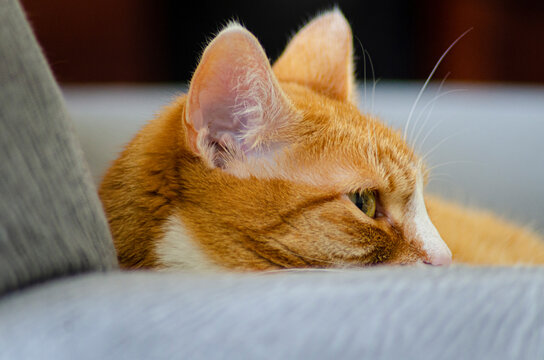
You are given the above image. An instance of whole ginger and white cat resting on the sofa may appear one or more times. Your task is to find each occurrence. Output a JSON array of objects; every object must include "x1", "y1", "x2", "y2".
[{"x1": 100, "y1": 10, "x2": 544, "y2": 270}]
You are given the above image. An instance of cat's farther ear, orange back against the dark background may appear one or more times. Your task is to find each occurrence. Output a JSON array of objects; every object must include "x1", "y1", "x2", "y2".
[{"x1": 273, "y1": 9, "x2": 355, "y2": 101}]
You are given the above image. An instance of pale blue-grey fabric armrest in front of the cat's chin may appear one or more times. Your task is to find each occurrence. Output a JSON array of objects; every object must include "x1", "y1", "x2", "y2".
[{"x1": 0, "y1": 267, "x2": 544, "y2": 359}]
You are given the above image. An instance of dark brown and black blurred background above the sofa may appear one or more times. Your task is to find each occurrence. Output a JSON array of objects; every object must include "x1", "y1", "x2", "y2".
[{"x1": 22, "y1": 0, "x2": 544, "y2": 83}]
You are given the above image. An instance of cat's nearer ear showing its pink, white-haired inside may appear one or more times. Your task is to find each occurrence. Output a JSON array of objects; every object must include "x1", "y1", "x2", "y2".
[{"x1": 185, "y1": 24, "x2": 295, "y2": 167}]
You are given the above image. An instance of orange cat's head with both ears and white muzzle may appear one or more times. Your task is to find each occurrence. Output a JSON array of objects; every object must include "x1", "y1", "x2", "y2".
[{"x1": 172, "y1": 10, "x2": 451, "y2": 269}]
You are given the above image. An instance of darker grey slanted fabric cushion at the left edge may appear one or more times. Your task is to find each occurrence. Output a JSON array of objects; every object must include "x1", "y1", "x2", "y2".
[{"x1": 0, "y1": 0, "x2": 116, "y2": 294}]
